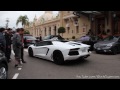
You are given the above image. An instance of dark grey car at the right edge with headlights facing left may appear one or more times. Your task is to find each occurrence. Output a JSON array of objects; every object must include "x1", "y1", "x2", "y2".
[{"x1": 94, "y1": 36, "x2": 120, "y2": 55}]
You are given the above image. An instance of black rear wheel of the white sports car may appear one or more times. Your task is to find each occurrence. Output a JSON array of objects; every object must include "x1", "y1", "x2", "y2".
[{"x1": 53, "y1": 50, "x2": 64, "y2": 65}]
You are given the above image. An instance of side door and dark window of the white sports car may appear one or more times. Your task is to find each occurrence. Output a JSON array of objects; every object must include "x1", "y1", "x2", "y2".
[{"x1": 34, "y1": 41, "x2": 52, "y2": 57}]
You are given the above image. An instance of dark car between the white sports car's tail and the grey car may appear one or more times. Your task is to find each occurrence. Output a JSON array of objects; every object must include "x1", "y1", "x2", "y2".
[{"x1": 74, "y1": 35, "x2": 101, "y2": 51}]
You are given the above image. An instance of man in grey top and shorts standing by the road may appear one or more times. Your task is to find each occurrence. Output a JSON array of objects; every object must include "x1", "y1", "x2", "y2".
[{"x1": 13, "y1": 28, "x2": 22, "y2": 68}]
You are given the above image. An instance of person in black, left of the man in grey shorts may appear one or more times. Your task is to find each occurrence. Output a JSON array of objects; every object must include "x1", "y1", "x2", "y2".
[{"x1": 4, "y1": 28, "x2": 12, "y2": 62}]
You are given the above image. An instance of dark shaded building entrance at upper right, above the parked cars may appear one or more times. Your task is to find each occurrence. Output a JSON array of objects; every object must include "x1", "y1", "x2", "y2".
[{"x1": 75, "y1": 11, "x2": 120, "y2": 35}]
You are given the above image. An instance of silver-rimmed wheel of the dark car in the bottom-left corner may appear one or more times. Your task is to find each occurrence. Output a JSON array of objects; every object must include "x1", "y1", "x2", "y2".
[{"x1": 0, "y1": 64, "x2": 8, "y2": 79}]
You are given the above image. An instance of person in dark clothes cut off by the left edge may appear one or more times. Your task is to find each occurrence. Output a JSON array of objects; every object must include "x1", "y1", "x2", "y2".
[{"x1": 0, "y1": 28, "x2": 6, "y2": 53}]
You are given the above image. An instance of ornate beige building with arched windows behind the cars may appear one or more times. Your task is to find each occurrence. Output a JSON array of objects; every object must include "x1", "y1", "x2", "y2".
[{"x1": 25, "y1": 11, "x2": 90, "y2": 39}]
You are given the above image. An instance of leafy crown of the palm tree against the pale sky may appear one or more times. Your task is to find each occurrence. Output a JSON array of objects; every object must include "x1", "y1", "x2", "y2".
[{"x1": 16, "y1": 15, "x2": 29, "y2": 27}]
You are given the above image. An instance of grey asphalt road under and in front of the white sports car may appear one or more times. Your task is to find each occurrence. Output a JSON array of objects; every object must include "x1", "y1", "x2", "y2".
[{"x1": 8, "y1": 50, "x2": 120, "y2": 79}]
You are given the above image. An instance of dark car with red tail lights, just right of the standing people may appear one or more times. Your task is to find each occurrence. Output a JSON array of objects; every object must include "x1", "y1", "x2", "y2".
[{"x1": 23, "y1": 34, "x2": 37, "y2": 47}]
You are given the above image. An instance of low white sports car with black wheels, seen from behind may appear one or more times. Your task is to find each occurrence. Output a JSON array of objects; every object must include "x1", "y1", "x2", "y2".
[{"x1": 28, "y1": 40, "x2": 90, "y2": 64}]
